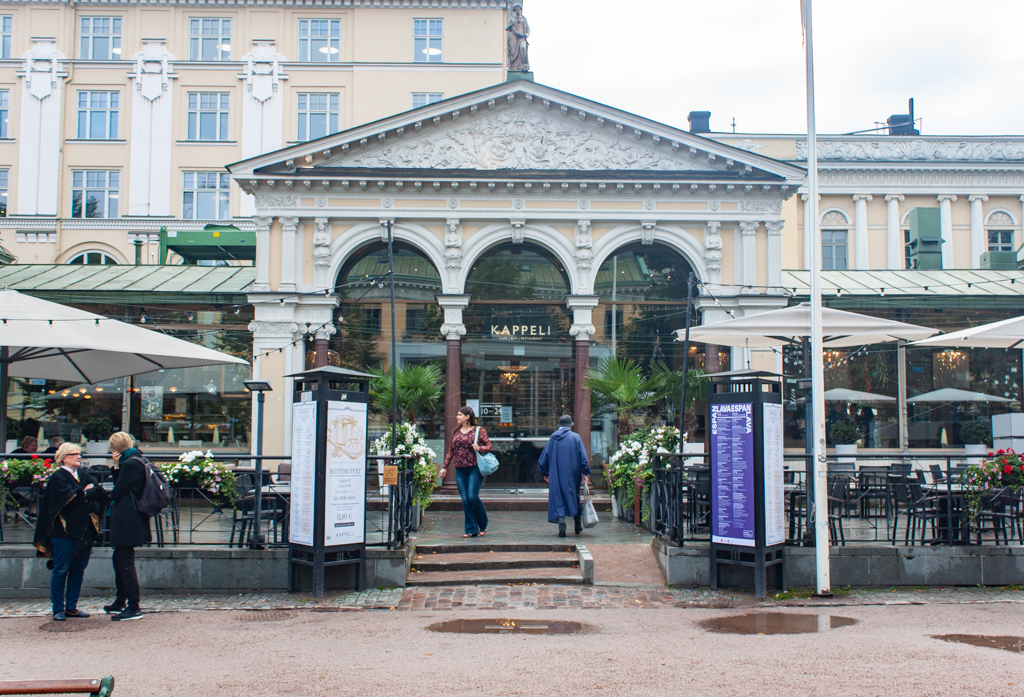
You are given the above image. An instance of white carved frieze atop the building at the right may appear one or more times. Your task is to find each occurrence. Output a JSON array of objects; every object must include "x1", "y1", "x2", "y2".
[{"x1": 797, "y1": 139, "x2": 1024, "y2": 162}]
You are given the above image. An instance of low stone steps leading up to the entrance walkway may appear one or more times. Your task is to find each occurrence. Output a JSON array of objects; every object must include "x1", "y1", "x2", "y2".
[{"x1": 406, "y1": 542, "x2": 594, "y2": 585}]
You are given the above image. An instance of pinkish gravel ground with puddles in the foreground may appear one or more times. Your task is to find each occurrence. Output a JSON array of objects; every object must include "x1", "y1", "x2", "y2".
[{"x1": 0, "y1": 603, "x2": 1024, "y2": 697}]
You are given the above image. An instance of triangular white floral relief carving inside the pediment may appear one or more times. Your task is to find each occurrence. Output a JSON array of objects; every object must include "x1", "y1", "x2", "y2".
[{"x1": 335, "y1": 110, "x2": 697, "y2": 170}]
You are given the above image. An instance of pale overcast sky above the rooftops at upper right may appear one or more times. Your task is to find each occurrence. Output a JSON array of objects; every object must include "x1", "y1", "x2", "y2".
[{"x1": 522, "y1": 0, "x2": 1024, "y2": 135}]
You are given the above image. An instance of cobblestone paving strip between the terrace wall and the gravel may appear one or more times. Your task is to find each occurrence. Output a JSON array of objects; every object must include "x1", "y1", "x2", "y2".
[{"x1": 0, "y1": 584, "x2": 1024, "y2": 618}]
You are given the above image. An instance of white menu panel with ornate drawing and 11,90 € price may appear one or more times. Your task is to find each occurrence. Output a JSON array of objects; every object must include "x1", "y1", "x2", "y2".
[{"x1": 324, "y1": 401, "x2": 367, "y2": 547}]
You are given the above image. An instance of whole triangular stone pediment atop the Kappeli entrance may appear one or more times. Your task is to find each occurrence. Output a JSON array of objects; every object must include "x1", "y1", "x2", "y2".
[{"x1": 229, "y1": 81, "x2": 804, "y2": 185}]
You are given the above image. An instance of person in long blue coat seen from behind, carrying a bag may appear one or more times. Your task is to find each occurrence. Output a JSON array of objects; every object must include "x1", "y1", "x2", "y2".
[{"x1": 537, "y1": 415, "x2": 590, "y2": 537}]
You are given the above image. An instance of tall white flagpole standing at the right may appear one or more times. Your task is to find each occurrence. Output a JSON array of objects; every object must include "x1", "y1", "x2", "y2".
[{"x1": 801, "y1": 0, "x2": 831, "y2": 595}]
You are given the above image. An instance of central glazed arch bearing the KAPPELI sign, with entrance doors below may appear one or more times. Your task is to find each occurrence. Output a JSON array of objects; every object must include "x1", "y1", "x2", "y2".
[{"x1": 462, "y1": 243, "x2": 575, "y2": 486}]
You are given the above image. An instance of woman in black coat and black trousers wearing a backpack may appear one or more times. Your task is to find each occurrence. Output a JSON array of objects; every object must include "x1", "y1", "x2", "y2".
[{"x1": 103, "y1": 431, "x2": 153, "y2": 621}]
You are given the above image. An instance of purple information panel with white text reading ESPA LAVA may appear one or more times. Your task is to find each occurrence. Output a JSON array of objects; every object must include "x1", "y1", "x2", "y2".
[{"x1": 711, "y1": 402, "x2": 755, "y2": 547}]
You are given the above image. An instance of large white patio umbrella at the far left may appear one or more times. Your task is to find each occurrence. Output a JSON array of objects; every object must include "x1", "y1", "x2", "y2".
[{"x1": 0, "y1": 290, "x2": 248, "y2": 446}]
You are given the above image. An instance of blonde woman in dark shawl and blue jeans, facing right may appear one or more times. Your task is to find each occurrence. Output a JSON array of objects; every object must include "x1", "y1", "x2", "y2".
[{"x1": 33, "y1": 443, "x2": 106, "y2": 622}]
